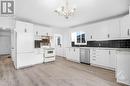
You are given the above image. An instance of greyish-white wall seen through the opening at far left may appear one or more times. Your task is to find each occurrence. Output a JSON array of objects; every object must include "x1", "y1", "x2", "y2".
[{"x1": 0, "y1": 30, "x2": 11, "y2": 54}]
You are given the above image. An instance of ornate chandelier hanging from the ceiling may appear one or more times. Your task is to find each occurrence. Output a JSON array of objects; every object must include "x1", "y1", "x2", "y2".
[{"x1": 54, "y1": 0, "x2": 76, "y2": 19}]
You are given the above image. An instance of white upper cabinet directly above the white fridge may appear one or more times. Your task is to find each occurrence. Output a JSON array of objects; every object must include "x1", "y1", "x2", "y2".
[{"x1": 15, "y1": 21, "x2": 33, "y2": 33}]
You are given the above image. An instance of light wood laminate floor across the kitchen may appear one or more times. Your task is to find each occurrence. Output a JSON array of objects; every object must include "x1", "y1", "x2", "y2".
[{"x1": 0, "y1": 57, "x2": 125, "y2": 86}]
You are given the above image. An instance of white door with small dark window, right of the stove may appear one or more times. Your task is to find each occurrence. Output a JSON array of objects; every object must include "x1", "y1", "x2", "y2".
[{"x1": 54, "y1": 34, "x2": 64, "y2": 57}]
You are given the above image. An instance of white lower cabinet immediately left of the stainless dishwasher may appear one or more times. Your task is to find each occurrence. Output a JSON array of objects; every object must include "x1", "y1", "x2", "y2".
[{"x1": 66, "y1": 48, "x2": 80, "y2": 63}]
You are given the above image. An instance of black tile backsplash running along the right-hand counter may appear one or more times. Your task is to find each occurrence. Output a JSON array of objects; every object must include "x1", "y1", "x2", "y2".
[{"x1": 71, "y1": 39, "x2": 130, "y2": 48}]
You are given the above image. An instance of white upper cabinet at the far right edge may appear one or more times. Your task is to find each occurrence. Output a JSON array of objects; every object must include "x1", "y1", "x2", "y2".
[{"x1": 120, "y1": 15, "x2": 130, "y2": 39}]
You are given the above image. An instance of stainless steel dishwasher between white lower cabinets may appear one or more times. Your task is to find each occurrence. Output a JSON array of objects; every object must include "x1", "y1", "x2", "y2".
[{"x1": 80, "y1": 48, "x2": 90, "y2": 64}]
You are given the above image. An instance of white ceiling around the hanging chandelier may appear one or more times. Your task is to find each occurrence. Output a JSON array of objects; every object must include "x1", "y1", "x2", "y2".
[{"x1": 15, "y1": 0, "x2": 130, "y2": 28}]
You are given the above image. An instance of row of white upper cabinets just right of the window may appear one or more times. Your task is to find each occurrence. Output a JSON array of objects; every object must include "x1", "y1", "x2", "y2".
[{"x1": 86, "y1": 19, "x2": 120, "y2": 41}]
